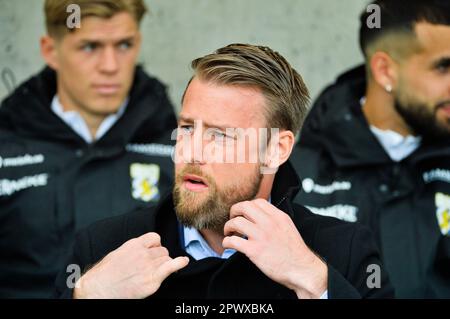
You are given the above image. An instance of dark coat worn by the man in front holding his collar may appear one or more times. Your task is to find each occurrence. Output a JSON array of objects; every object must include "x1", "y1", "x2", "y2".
[{"x1": 57, "y1": 164, "x2": 393, "y2": 299}]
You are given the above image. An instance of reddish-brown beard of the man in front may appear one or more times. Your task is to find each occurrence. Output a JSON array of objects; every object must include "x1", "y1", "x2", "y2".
[{"x1": 173, "y1": 165, "x2": 262, "y2": 234}]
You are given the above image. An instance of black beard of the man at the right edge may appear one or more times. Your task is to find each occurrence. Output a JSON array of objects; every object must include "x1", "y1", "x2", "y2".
[{"x1": 395, "y1": 97, "x2": 450, "y2": 140}]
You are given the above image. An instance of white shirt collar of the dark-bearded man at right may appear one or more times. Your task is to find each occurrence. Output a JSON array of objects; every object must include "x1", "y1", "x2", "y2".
[{"x1": 360, "y1": 97, "x2": 422, "y2": 162}]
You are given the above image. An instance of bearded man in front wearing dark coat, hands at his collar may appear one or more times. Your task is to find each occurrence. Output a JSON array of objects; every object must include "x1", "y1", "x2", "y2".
[{"x1": 57, "y1": 44, "x2": 393, "y2": 299}]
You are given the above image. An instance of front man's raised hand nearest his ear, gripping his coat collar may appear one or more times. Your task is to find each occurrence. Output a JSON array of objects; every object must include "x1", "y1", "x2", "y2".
[{"x1": 223, "y1": 199, "x2": 328, "y2": 298}]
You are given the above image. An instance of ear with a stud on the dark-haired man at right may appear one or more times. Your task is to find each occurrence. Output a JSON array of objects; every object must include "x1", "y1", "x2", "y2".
[{"x1": 370, "y1": 51, "x2": 398, "y2": 93}]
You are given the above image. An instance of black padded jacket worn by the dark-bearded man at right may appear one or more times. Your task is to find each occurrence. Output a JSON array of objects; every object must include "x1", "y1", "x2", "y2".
[{"x1": 292, "y1": 67, "x2": 450, "y2": 298}]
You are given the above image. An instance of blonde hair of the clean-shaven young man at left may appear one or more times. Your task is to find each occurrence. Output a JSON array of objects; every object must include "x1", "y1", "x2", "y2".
[{"x1": 44, "y1": 0, "x2": 147, "y2": 38}]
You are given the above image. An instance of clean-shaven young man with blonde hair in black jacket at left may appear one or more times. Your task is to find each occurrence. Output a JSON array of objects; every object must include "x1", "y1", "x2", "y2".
[{"x1": 0, "y1": 0, "x2": 176, "y2": 298}]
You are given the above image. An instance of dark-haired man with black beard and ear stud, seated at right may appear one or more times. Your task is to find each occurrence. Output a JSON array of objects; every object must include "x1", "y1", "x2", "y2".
[{"x1": 292, "y1": 0, "x2": 450, "y2": 298}]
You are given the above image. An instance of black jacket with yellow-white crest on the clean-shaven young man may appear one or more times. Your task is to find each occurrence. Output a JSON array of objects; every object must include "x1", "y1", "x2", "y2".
[{"x1": 0, "y1": 67, "x2": 176, "y2": 298}]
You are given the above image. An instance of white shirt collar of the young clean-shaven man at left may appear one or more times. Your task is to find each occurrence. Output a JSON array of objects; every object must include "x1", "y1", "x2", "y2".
[{"x1": 51, "y1": 95, "x2": 128, "y2": 144}]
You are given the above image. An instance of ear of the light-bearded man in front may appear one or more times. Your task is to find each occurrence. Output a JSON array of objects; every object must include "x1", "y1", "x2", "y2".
[{"x1": 265, "y1": 130, "x2": 295, "y2": 172}]
